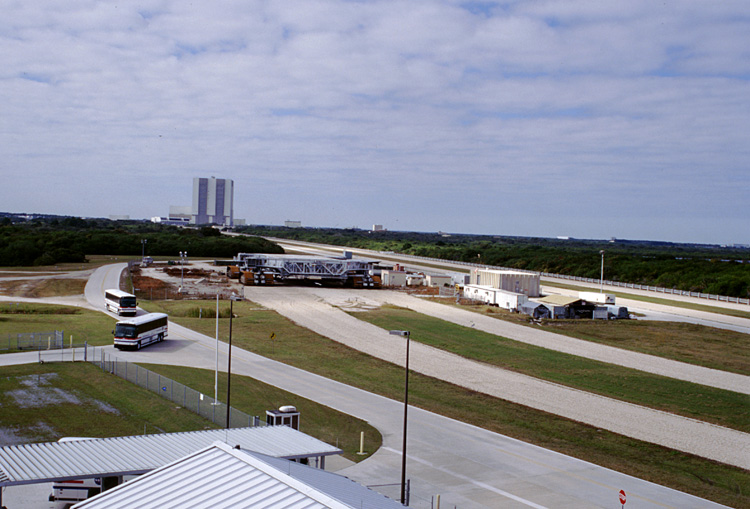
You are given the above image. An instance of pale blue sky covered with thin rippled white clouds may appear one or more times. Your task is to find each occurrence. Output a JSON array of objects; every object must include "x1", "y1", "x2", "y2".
[{"x1": 0, "y1": 0, "x2": 750, "y2": 244}]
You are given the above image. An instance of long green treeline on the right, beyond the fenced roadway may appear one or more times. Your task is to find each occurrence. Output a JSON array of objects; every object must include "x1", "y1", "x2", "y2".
[{"x1": 242, "y1": 226, "x2": 750, "y2": 298}]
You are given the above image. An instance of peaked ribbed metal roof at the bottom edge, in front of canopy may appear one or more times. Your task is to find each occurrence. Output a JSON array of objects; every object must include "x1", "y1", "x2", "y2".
[{"x1": 74, "y1": 443, "x2": 403, "y2": 509}]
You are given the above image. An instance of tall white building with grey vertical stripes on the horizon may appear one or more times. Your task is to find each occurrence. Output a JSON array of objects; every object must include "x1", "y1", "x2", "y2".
[{"x1": 190, "y1": 177, "x2": 234, "y2": 226}]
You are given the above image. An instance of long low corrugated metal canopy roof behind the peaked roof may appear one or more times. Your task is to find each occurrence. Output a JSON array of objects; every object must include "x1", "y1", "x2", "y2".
[{"x1": 0, "y1": 426, "x2": 341, "y2": 486}]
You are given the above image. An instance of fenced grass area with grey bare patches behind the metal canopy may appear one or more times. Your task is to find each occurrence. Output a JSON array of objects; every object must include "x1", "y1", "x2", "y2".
[{"x1": 0, "y1": 362, "x2": 215, "y2": 445}]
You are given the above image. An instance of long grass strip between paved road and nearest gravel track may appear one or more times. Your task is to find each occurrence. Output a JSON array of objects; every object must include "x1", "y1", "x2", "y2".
[{"x1": 143, "y1": 301, "x2": 750, "y2": 507}]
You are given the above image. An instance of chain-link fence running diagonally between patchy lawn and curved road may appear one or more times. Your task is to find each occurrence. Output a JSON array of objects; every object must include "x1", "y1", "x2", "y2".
[{"x1": 93, "y1": 351, "x2": 265, "y2": 428}]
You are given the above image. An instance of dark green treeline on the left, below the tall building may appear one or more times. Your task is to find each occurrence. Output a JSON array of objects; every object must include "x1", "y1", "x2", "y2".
[{"x1": 0, "y1": 217, "x2": 283, "y2": 267}]
